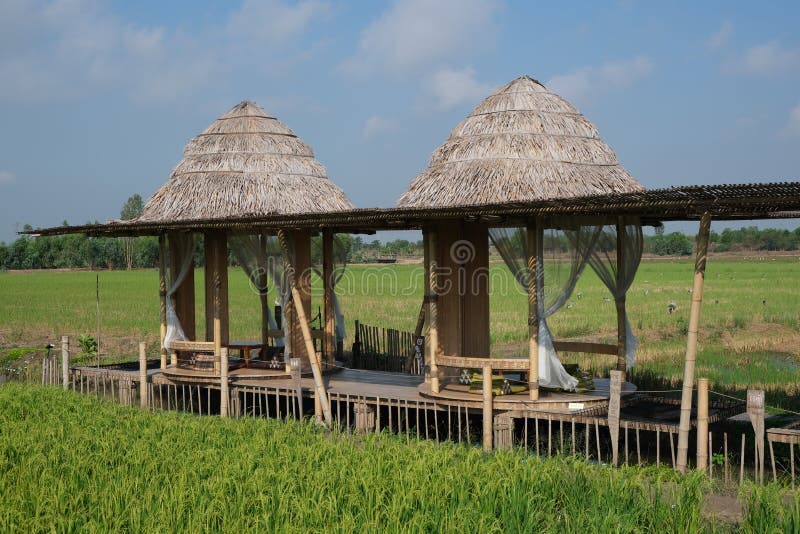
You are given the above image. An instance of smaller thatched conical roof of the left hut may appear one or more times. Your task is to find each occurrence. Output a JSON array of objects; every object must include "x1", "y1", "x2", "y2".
[{"x1": 138, "y1": 102, "x2": 353, "y2": 221}]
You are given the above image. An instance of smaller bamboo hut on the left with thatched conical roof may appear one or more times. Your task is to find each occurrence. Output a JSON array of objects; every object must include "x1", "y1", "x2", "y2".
[{"x1": 139, "y1": 102, "x2": 353, "y2": 408}]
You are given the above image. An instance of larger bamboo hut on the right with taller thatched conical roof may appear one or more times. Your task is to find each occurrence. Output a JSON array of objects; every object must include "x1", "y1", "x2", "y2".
[{"x1": 398, "y1": 76, "x2": 643, "y2": 412}]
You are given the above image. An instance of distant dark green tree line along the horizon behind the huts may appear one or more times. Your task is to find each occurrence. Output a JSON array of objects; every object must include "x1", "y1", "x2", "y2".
[{"x1": 0, "y1": 195, "x2": 800, "y2": 270}]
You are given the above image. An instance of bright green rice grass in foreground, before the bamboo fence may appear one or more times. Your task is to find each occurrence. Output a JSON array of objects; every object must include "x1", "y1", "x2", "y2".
[{"x1": 0, "y1": 385, "x2": 756, "y2": 532}]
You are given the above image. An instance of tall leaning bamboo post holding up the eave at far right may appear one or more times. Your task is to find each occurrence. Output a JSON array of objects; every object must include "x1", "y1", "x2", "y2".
[{"x1": 676, "y1": 212, "x2": 711, "y2": 474}]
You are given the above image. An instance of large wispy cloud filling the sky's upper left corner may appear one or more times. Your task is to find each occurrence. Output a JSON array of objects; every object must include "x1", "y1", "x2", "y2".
[{"x1": 0, "y1": 0, "x2": 328, "y2": 100}]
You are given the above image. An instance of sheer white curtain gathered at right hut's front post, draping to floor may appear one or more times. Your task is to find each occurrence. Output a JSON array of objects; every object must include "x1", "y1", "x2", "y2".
[{"x1": 489, "y1": 223, "x2": 600, "y2": 390}]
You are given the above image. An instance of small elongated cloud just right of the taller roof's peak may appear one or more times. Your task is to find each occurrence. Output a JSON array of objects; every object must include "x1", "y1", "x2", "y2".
[{"x1": 546, "y1": 56, "x2": 653, "y2": 107}]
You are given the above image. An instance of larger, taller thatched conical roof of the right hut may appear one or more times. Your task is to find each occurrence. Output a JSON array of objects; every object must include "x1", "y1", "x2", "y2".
[{"x1": 397, "y1": 76, "x2": 643, "y2": 207}]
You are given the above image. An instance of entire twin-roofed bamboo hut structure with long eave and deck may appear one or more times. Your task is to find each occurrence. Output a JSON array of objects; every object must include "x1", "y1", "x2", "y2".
[{"x1": 23, "y1": 81, "x2": 800, "y2": 462}]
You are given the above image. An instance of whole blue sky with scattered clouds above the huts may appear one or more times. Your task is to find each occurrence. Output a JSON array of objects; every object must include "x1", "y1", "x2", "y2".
[{"x1": 0, "y1": 0, "x2": 800, "y2": 241}]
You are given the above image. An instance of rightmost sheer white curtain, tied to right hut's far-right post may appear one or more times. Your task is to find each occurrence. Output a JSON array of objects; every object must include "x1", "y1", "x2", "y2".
[{"x1": 589, "y1": 217, "x2": 643, "y2": 369}]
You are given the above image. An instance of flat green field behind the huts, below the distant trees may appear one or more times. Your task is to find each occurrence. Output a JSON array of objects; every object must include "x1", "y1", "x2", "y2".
[{"x1": 0, "y1": 256, "x2": 800, "y2": 405}]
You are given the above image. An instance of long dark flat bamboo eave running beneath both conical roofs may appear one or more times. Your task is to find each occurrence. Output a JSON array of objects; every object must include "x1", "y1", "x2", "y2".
[{"x1": 21, "y1": 181, "x2": 800, "y2": 236}]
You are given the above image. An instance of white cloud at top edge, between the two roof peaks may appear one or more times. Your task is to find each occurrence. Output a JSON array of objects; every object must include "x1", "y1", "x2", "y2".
[{"x1": 341, "y1": 0, "x2": 497, "y2": 76}]
